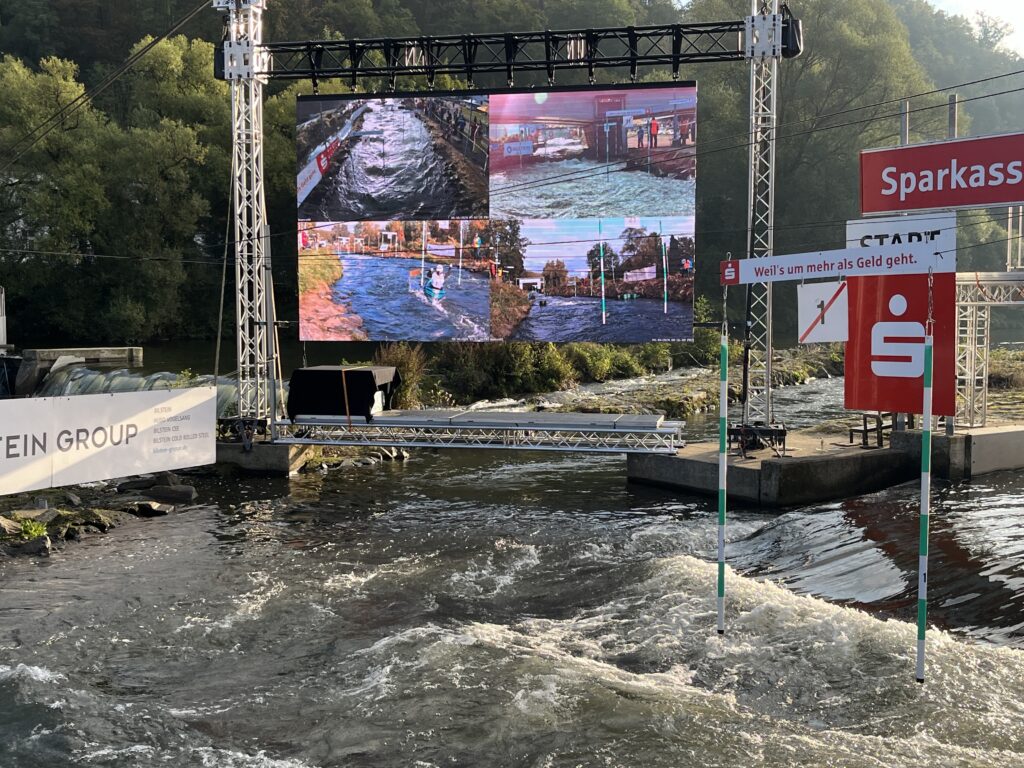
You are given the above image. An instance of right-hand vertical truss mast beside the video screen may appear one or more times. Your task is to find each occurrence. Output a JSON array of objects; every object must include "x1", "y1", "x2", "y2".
[{"x1": 743, "y1": 0, "x2": 782, "y2": 424}]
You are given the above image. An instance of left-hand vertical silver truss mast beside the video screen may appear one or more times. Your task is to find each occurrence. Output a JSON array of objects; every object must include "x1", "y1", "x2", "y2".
[{"x1": 213, "y1": 0, "x2": 274, "y2": 423}]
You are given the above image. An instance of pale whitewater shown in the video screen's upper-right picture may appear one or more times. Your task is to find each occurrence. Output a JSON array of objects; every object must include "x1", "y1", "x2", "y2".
[{"x1": 490, "y1": 160, "x2": 696, "y2": 219}]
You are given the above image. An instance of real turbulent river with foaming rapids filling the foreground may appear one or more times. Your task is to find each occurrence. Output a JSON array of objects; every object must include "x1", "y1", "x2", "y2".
[{"x1": 0, "y1": 383, "x2": 1024, "y2": 768}]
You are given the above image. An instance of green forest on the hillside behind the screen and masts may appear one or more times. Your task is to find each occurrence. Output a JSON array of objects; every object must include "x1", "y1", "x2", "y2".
[{"x1": 0, "y1": 0, "x2": 1024, "y2": 343}]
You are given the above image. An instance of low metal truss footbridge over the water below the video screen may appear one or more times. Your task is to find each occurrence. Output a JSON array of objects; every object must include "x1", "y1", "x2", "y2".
[{"x1": 271, "y1": 409, "x2": 685, "y2": 454}]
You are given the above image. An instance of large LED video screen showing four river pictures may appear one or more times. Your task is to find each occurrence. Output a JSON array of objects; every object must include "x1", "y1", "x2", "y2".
[{"x1": 296, "y1": 83, "x2": 696, "y2": 343}]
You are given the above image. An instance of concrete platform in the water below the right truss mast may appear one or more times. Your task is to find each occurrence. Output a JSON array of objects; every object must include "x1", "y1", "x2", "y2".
[{"x1": 627, "y1": 433, "x2": 921, "y2": 508}]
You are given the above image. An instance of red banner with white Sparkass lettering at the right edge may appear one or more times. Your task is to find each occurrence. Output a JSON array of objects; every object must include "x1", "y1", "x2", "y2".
[{"x1": 860, "y1": 133, "x2": 1024, "y2": 215}]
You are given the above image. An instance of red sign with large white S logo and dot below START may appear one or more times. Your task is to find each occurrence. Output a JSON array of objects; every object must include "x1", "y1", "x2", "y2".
[{"x1": 845, "y1": 272, "x2": 956, "y2": 416}]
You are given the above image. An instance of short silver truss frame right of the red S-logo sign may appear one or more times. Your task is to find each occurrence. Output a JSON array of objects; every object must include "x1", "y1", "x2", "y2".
[{"x1": 956, "y1": 271, "x2": 1024, "y2": 427}]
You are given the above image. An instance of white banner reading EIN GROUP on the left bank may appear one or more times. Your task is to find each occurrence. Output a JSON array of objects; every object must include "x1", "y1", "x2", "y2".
[{"x1": 0, "y1": 387, "x2": 217, "y2": 495}]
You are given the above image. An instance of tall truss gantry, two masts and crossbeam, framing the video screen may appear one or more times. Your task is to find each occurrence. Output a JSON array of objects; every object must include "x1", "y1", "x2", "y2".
[{"x1": 213, "y1": 0, "x2": 802, "y2": 451}]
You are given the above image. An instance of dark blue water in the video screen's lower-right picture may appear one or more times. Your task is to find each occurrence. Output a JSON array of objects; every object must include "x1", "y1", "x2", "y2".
[{"x1": 512, "y1": 296, "x2": 693, "y2": 343}]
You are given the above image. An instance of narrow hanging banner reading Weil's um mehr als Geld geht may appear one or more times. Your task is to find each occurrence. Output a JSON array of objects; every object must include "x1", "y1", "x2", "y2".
[{"x1": 720, "y1": 243, "x2": 956, "y2": 286}]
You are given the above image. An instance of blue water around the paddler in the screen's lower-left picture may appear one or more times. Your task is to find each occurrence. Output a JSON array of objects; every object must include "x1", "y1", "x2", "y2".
[{"x1": 332, "y1": 255, "x2": 490, "y2": 341}]
